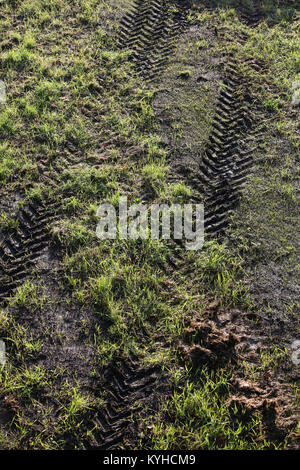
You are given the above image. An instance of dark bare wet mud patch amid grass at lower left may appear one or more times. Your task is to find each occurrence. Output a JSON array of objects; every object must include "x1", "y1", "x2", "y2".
[{"x1": 7, "y1": 272, "x2": 101, "y2": 386}]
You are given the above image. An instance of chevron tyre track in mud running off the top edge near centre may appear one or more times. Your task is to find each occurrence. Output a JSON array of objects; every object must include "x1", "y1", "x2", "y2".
[{"x1": 119, "y1": 0, "x2": 188, "y2": 80}]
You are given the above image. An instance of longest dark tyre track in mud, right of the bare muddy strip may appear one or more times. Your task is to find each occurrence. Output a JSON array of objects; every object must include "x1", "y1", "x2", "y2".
[{"x1": 202, "y1": 60, "x2": 260, "y2": 236}]
